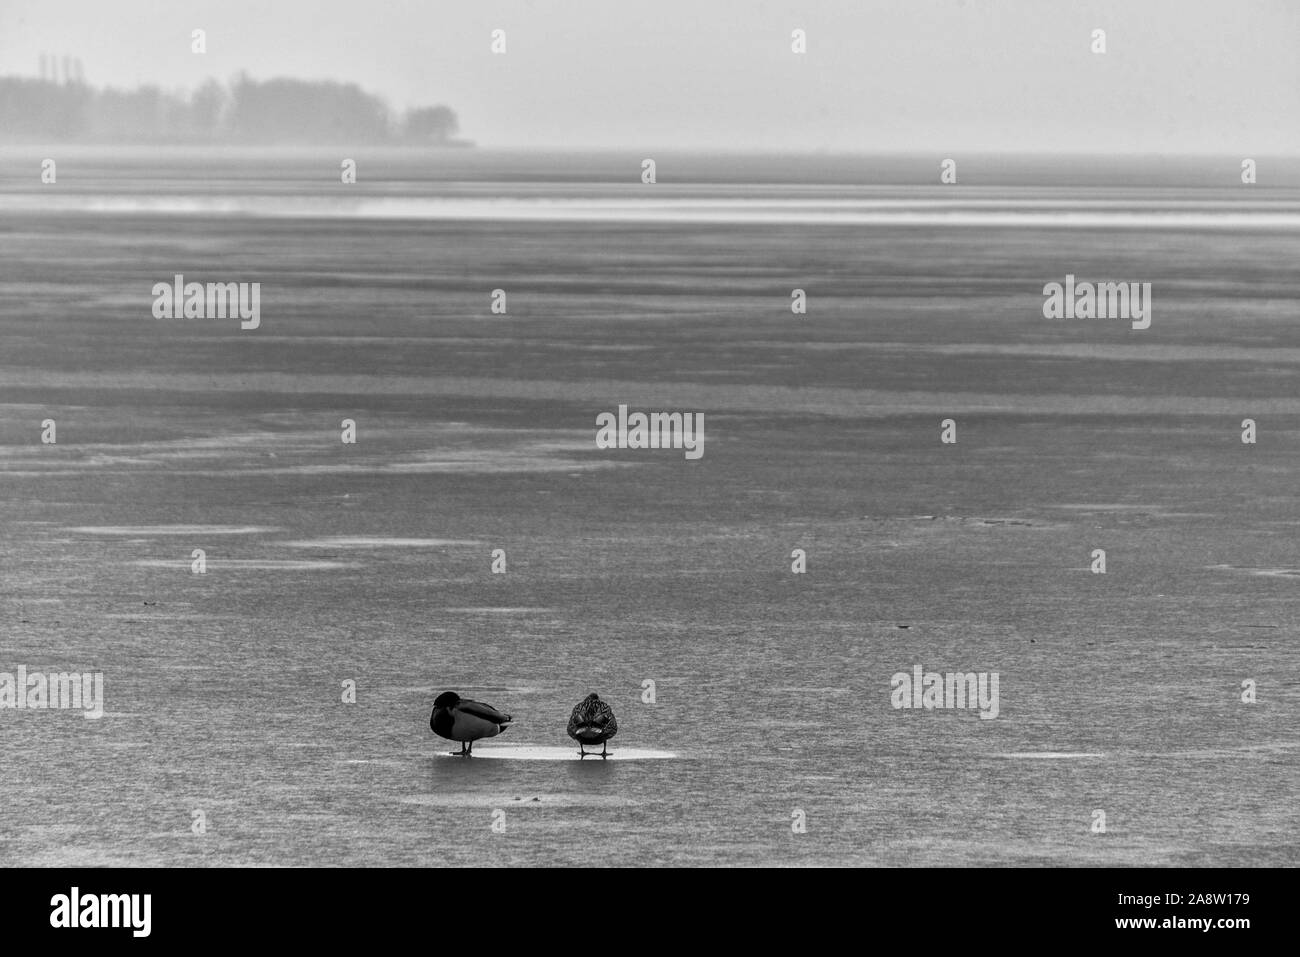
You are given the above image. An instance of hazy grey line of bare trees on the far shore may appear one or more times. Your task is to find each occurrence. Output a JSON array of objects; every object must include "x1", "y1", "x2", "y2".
[{"x1": 0, "y1": 74, "x2": 458, "y2": 144}]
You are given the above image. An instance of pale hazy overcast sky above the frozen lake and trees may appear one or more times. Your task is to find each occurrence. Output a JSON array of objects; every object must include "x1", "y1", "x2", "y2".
[{"x1": 0, "y1": 0, "x2": 1300, "y2": 156}]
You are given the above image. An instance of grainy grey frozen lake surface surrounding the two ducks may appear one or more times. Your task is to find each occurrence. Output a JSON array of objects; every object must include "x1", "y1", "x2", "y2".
[{"x1": 0, "y1": 152, "x2": 1300, "y2": 865}]
